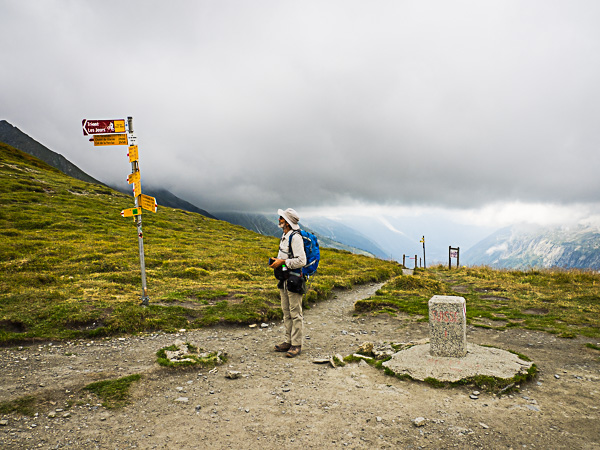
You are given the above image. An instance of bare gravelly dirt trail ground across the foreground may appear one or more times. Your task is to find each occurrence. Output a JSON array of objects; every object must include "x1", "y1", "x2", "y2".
[{"x1": 0, "y1": 285, "x2": 600, "y2": 449}]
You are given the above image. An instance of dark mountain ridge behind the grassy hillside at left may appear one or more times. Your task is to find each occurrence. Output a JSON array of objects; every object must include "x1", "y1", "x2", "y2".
[{"x1": 0, "y1": 120, "x2": 216, "y2": 219}]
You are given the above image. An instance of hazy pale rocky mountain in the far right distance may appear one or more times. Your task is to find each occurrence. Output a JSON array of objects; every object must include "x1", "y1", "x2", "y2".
[{"x1": 461, "y1": 224, "x2": 600, "y2": 270}]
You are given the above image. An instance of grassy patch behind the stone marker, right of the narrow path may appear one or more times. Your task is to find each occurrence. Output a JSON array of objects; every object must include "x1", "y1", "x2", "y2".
[{"x1": 356, "y1": 266, "x2": 600, "y2": 338}]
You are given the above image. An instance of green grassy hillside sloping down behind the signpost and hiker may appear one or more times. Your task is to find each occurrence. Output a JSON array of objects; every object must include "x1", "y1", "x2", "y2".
[{"x1": 0, "y1": 143, "x2": 400, "y2": 343}]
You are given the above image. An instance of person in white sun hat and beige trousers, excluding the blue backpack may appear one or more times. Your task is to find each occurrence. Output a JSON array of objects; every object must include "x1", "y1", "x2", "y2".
[{"x1": 269, "y1": 208, "x2": 306, "y2": 358}]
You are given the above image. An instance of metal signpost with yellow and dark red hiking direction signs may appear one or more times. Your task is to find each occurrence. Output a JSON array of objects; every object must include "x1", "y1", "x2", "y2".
[{"x1": 81, "y1": 117, "x2": 158, "y2": 306}]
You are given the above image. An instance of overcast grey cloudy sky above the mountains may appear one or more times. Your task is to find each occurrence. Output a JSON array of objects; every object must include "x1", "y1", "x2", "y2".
[{"x1": 0, "y1": 0, "x2": 600, "y2": 229}]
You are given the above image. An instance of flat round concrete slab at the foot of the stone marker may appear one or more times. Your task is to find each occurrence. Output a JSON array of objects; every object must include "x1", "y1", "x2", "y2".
[{"x1": 383, "y1": 344, "x2": 533, "y2": 382}]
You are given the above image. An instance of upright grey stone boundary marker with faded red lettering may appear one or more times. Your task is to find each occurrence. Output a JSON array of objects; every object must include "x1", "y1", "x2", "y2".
[{"x1": 429, "y1": 295, "x2": 467, "y2": 358}]
